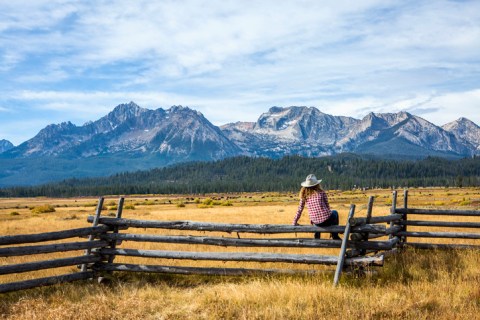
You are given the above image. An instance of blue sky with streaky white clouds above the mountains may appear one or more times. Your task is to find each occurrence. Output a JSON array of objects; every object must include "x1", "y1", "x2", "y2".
[{"x1": 0, "y1": 0, "x2": 480, "y2": 145}]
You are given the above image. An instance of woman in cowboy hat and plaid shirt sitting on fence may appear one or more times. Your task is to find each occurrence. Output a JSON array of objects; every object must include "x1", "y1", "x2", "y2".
[{"x1": 293, "y1": 174, "x2": 341, "y2": 240}]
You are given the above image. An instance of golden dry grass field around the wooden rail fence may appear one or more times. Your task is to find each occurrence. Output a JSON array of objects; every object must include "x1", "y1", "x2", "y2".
[{"x1": 0, "y1": 188, "x2": 480, "y2": 319}]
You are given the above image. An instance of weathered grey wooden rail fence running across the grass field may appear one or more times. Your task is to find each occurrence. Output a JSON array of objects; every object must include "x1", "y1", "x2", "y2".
[{"x1": 0, "y1": 190, "x2": 480, "y2": 293}]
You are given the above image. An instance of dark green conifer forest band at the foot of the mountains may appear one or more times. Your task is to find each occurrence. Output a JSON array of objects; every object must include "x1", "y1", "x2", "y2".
[{"x1": 0, "y1": 154, "x2": 480, "y2": 197}]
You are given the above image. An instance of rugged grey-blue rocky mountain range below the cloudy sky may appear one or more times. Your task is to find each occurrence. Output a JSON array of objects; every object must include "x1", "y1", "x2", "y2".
[{"x1": 0, "y1": 102, "x2": 480, "y2": 186}]
